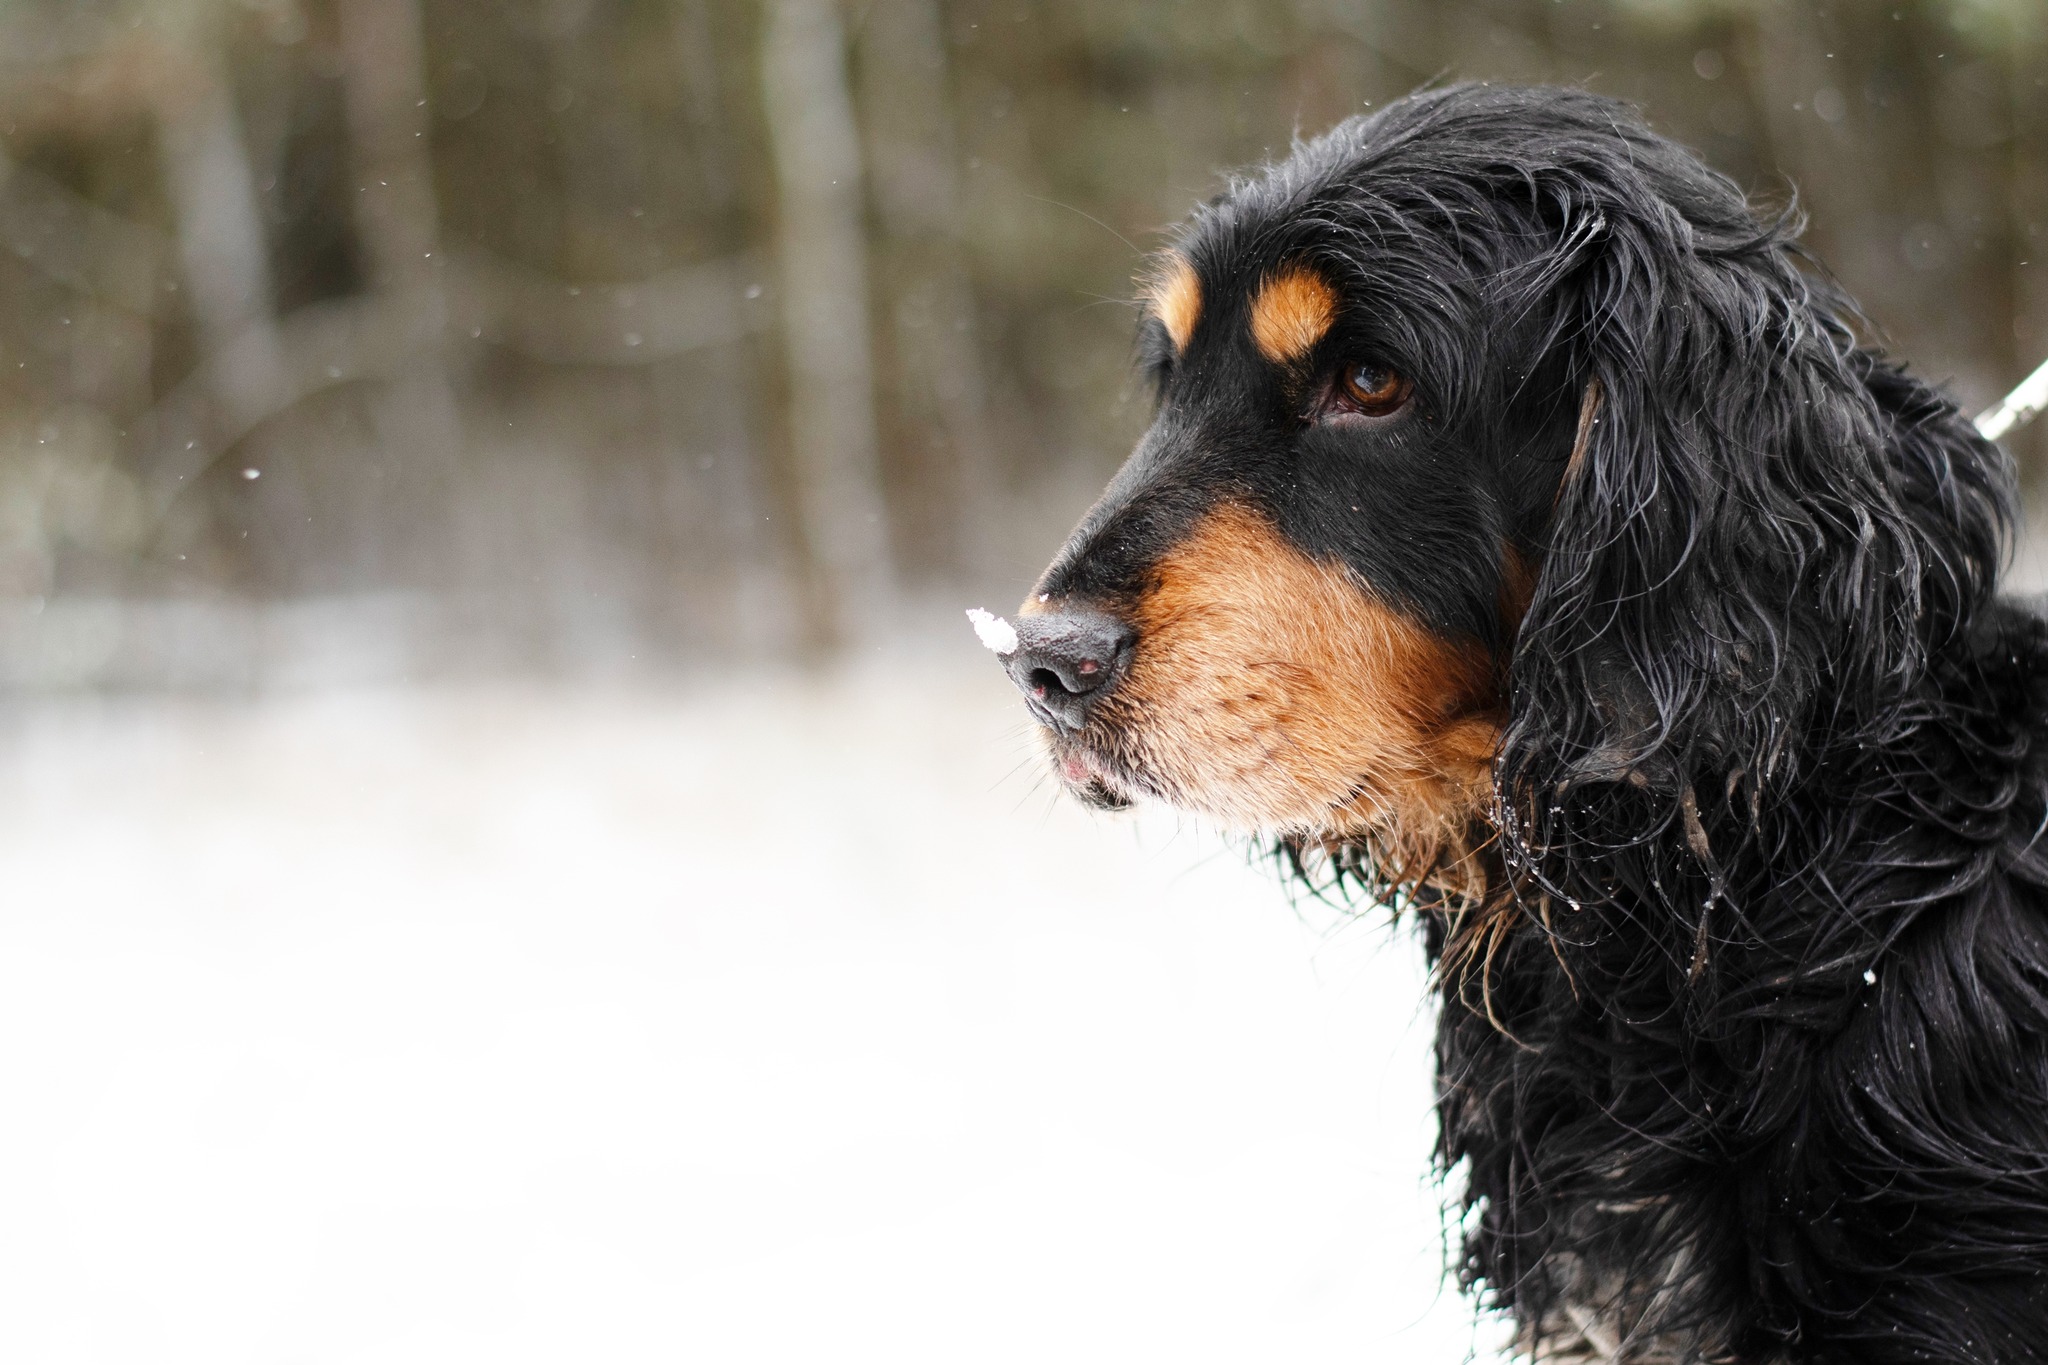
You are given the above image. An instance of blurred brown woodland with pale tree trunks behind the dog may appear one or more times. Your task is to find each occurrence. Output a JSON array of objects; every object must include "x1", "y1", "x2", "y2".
[{"x1": 0, "y1": 0, "x2": 2048, "y2": 690}]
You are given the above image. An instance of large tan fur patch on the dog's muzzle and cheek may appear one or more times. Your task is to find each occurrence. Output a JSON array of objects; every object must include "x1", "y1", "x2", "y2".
[{"x1": 1102, "y1": 505, "x2": 1499, "y2": 855}]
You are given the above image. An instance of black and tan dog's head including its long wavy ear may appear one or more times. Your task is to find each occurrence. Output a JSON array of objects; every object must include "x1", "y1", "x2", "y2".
[{"x1": 1008, "y1": 86, "x2": 2009, "y2": 896}]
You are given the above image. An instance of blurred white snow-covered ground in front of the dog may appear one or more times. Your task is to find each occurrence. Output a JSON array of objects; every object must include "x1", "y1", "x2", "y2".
[{"x1": 0, "y1": 630, "x2": 1485, "y2": 1365}]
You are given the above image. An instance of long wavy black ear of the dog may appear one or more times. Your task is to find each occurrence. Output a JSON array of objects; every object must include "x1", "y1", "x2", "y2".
[{"x1": 1497, "y1": 194, "x2": 2011, "y2": 890}]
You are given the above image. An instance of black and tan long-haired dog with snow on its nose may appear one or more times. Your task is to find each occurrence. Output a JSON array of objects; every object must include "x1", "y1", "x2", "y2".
[{"x1": 1001, "y1": 86, "x2": 2048, "y2": 1363}]
